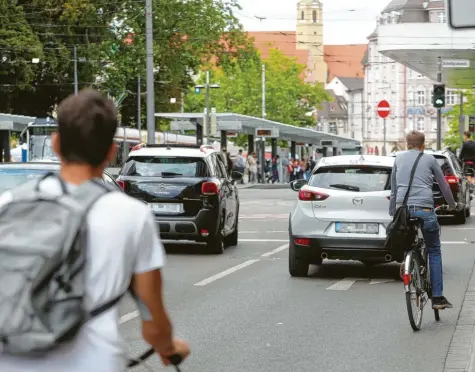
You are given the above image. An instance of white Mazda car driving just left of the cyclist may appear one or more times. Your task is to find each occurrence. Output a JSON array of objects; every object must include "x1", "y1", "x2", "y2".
[{"x1": 289, "y1": 155, "x2": 394, "y2": 276}]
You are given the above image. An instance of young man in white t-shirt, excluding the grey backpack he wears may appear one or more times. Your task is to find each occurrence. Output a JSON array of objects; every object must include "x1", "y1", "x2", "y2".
[{"x1": 0, "y1": 90, "x2": 189, "y2": 372}]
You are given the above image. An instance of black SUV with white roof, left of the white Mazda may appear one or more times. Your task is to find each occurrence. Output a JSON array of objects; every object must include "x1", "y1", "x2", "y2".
[{"x1": 116, "y1": 144, "x2": 242, "y2": 254}]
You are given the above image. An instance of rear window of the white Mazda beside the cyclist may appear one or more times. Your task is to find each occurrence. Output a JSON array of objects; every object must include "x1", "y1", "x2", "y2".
[{"x1": 308, "y1": 166, "x2": 391, "y2": 192}]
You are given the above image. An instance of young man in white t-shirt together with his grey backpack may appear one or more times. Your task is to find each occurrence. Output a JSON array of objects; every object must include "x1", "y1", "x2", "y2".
[{"x1": 0, "y1": 90, "x2": 189, "y2": 372}]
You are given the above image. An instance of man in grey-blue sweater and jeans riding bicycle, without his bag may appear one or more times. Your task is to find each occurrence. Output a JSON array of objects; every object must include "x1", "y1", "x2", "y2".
[{"x1": 389, "y1": 131, "x2": 457, "y2": 310}]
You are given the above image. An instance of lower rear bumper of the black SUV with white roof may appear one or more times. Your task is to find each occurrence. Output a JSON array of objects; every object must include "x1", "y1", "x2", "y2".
[{"x1": 155, "y1": 209, "x2": 218, "y2": 242}]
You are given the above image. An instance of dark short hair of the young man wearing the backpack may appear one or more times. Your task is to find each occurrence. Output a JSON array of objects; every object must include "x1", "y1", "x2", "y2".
[{"x1": 58, "y1": 89, "x2": 117, "y2": 167}]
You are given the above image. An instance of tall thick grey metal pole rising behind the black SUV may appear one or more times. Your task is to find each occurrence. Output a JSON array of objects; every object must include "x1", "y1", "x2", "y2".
[{"x1": 145, "y1": 0, "x2": 155, "y2": 145}]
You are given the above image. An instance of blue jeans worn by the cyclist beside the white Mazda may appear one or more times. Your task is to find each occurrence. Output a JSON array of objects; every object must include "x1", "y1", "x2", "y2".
[{"x1": 409, "y1": 207, "x2": 444, "y2": 297}]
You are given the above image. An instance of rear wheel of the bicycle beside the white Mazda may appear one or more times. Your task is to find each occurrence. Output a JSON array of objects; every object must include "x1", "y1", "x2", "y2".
[{"x1": 403, "y1": 251, "x2": 424, "y2": 331}]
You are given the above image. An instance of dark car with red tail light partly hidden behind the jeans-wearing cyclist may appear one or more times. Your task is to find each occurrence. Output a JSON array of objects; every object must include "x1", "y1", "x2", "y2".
[{"x1": 393, "y1": 150, "x2": 472, "y2": 224}]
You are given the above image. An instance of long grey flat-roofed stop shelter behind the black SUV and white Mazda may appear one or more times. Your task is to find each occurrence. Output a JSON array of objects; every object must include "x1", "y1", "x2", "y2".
[{"x1": 155, "y1": 113, "x2": 361, "y2": 157}]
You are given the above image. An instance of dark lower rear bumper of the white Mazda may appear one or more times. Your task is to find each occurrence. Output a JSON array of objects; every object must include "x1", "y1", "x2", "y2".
[{"x1": 292, "y1": 236, "x2": 392, "y2": 262}]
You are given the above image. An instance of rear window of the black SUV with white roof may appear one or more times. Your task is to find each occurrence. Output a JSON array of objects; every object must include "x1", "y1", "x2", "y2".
[{"x1": 121, "y1": 156, "x2": 208, "y2": 177}]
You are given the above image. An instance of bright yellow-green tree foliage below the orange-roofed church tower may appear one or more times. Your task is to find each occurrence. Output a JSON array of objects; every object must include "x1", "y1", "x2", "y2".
[{"x1": 185, "y1": 49, "x2": 331, "y2": 143}]
